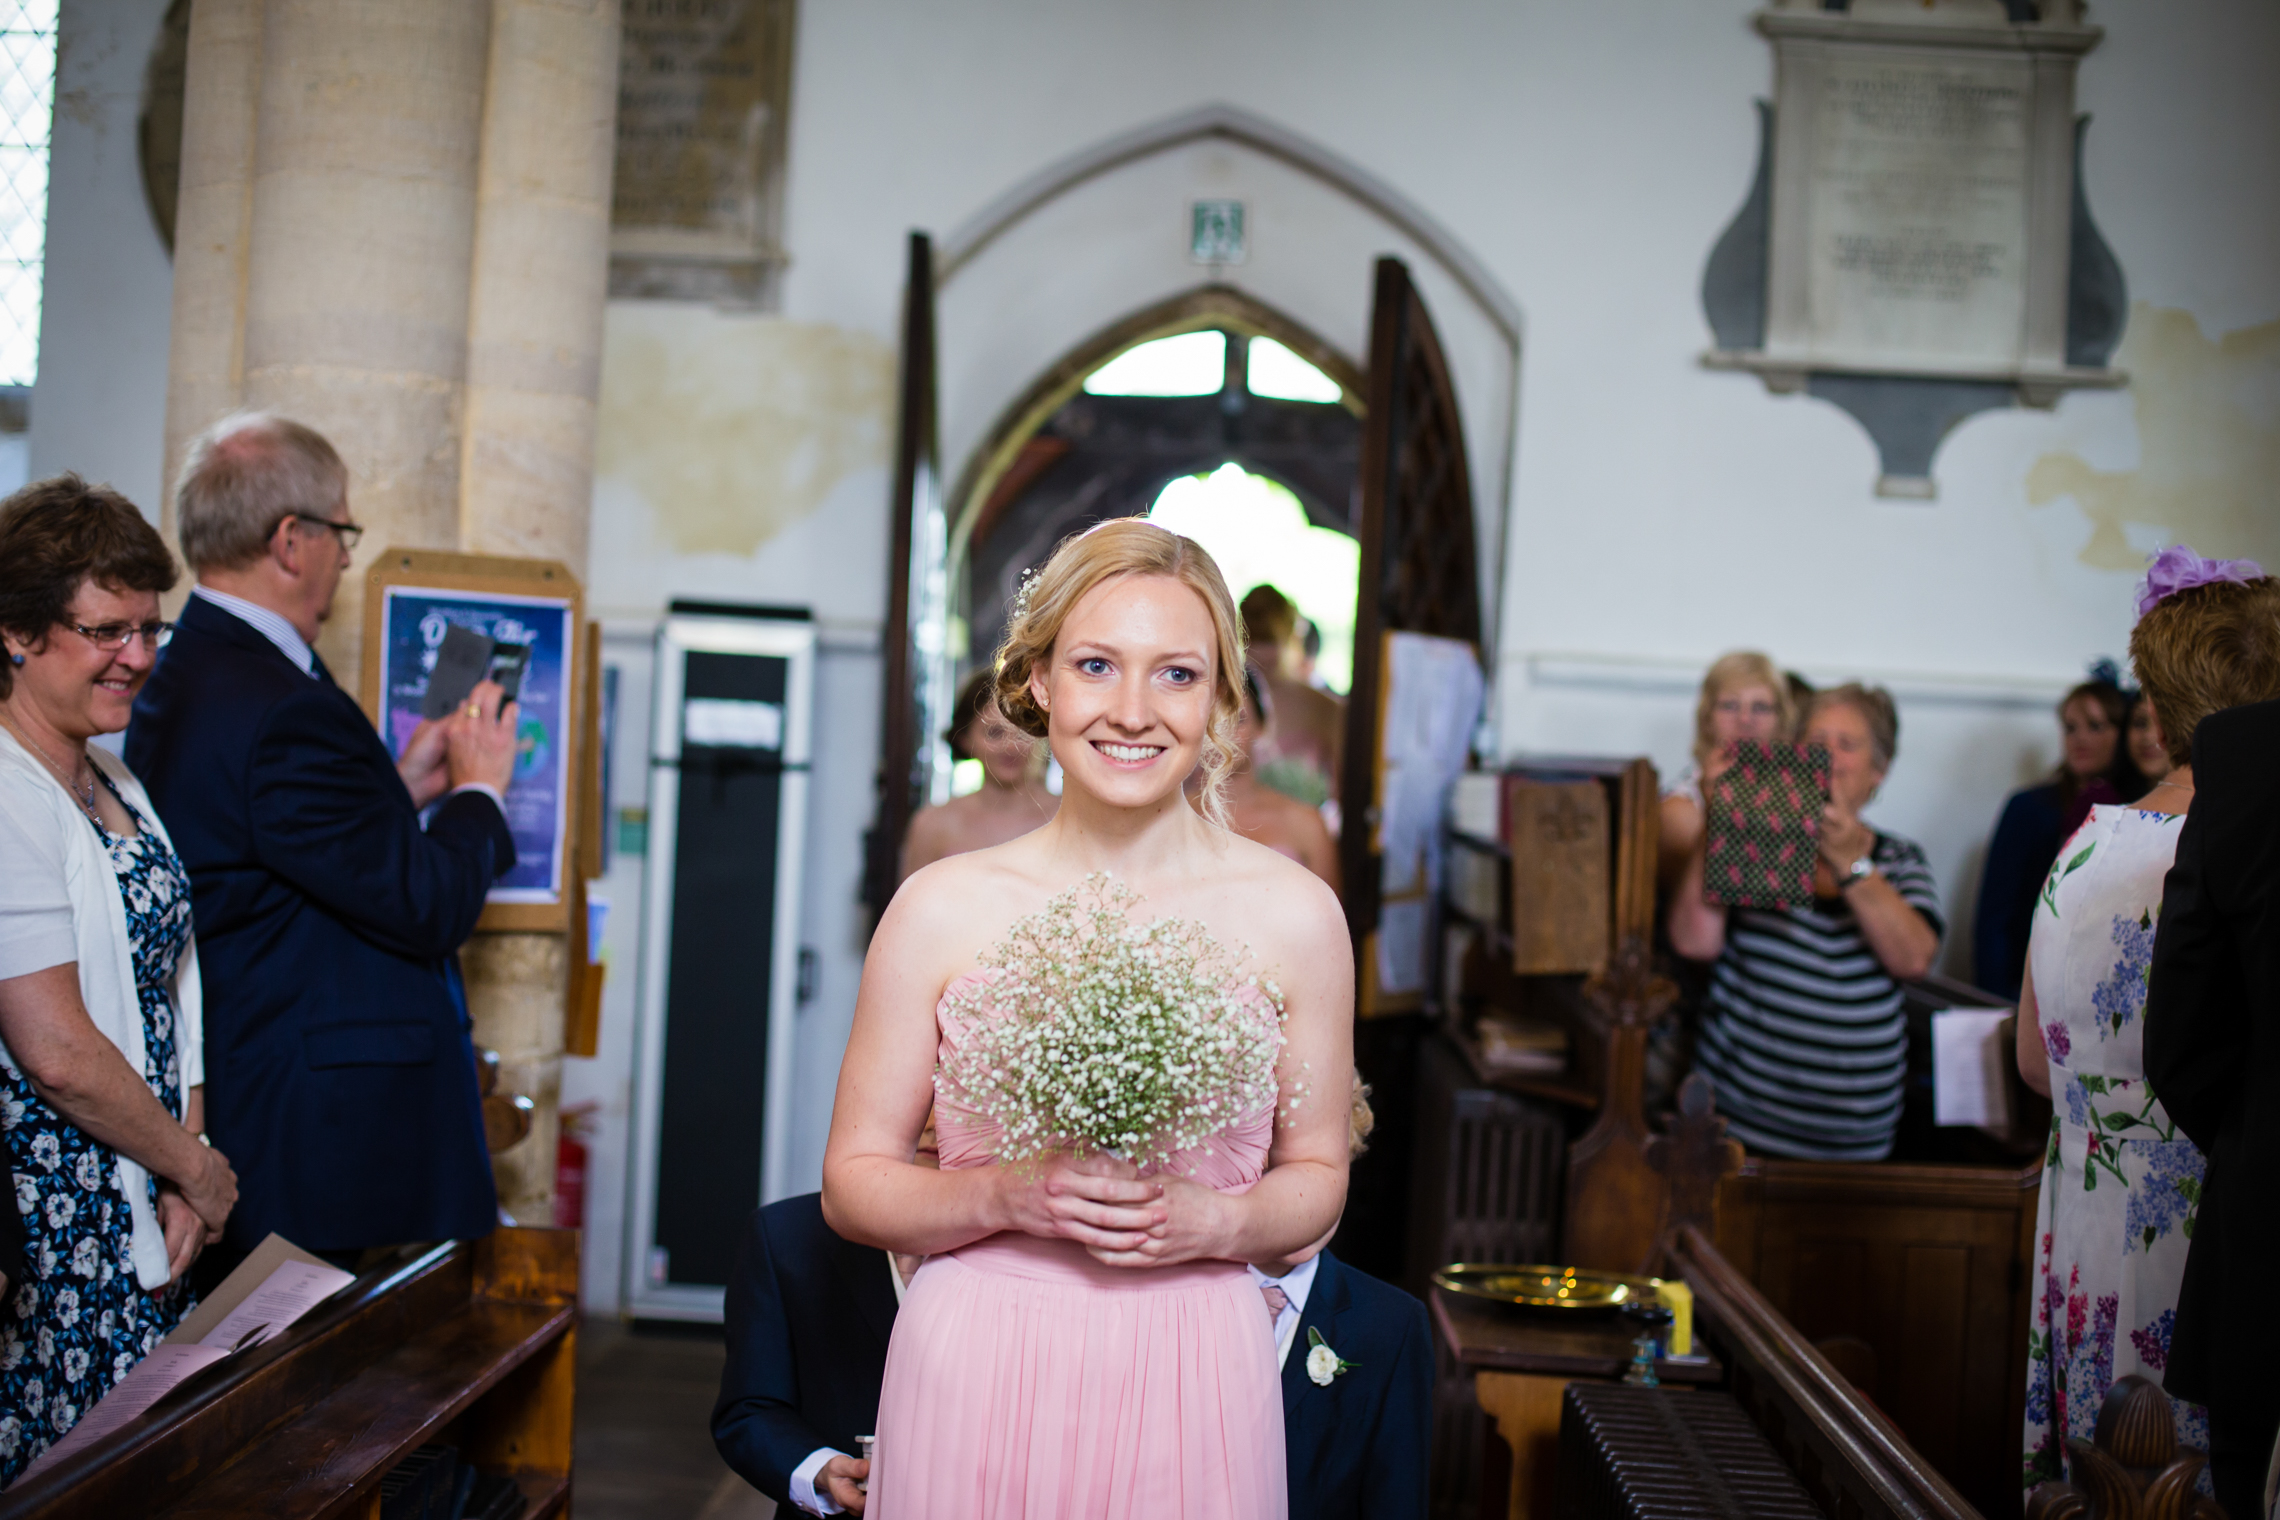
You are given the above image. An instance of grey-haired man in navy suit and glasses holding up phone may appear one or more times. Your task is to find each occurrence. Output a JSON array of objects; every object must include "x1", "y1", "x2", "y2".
[{"x1": 128, "y1": 415, "x2": 515, "y2": 1258}]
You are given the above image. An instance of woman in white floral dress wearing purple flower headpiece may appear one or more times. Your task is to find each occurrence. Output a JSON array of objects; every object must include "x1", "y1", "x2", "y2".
[{"x1": 2018, "y1": 547, "x2": 2280, "y2": 1488}]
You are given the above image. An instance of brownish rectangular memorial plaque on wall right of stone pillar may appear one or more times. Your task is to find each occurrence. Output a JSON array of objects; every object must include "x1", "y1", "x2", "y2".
[{"x1": 609, "y1": 0, "x2": 793, "y2": 308}]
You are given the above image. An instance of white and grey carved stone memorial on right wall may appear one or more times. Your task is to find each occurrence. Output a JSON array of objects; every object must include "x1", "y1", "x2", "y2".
[{"x1": 1703, "y1": 0, "x2": 2123, "y2": 497}]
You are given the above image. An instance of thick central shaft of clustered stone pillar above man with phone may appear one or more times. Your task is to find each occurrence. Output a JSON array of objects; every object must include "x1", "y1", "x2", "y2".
[{"x1": 238, "y1": 0, "x2": 490, "y2": 679}]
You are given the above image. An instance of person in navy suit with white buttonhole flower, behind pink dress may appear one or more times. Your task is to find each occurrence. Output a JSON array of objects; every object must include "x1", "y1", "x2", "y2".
[{"x1": 1249, "y1": 1073, "x2": 1432, "y2": 1520}]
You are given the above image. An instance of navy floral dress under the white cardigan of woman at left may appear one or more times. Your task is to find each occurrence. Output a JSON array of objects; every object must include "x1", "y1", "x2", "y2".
[{"x1": 0, "y1": 779, "x2": 192, "y2": 1486}]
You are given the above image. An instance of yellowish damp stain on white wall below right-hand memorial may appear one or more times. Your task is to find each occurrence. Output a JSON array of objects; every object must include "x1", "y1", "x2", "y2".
[{"x1": 2027, "y1": 303, "x2": 2280, "y2": 570}]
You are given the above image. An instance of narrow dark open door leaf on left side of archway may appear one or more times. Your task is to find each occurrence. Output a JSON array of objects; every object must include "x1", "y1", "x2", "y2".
[{"x1": 864, "y1": 232, "x2": 948, "y2": 923}]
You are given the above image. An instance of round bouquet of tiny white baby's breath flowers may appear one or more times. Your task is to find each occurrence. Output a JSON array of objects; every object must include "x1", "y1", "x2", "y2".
[{"x1": 935, "y1": 873, "x2": 1284, "y2": 1171}]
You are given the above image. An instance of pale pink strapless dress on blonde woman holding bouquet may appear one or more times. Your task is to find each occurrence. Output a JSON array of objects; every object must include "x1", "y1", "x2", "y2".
[{"x1": 866, "y1": 975, "x2": 1288, "y2": 1520}]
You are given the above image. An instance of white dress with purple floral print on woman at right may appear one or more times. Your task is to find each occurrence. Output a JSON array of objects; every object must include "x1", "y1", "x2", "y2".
[{"x1": 2025, "y1": 807, "x2": 2209, "y2": 1488}]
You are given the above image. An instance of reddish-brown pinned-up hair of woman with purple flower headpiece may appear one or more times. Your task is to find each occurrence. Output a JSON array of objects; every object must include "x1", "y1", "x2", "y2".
[{"x1": 2130, "y1": 577, "x2": 2280, "y2": 766}]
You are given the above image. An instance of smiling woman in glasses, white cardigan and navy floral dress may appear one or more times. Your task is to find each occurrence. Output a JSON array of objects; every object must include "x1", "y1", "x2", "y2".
[{"x1": 0, "y1": 487, "x2": 237, "y2": 1486}]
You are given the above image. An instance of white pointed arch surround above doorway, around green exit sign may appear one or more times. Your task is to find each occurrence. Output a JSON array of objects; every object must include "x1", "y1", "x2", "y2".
[{"x1": 935, "y1": 105, "x2": 1523, "y2": 649}]
